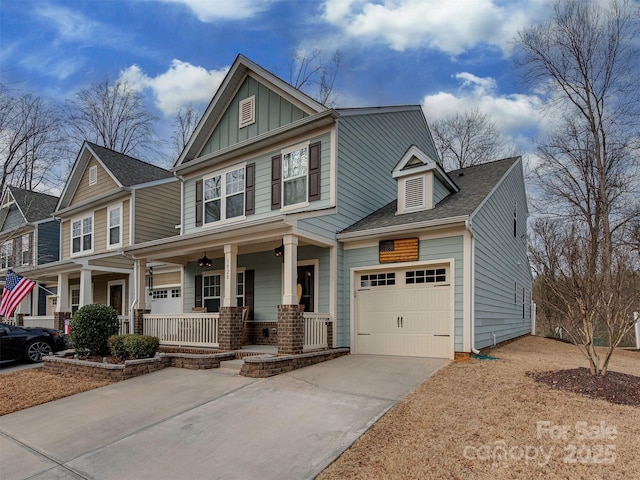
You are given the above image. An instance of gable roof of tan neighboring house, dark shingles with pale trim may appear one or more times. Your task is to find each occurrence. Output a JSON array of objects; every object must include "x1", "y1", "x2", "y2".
[{"x1": 57, "y1": 141, "x2": 174, "y2": 210}]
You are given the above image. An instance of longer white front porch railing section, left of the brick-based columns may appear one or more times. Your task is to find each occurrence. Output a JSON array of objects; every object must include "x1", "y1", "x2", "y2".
[{"x1": 142, "y1": 313, "x2": 220, "y2": 347}]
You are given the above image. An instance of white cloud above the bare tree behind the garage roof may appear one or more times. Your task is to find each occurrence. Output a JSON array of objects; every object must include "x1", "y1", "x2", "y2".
[{"x1": 422, "y1": 72, "x2": 546, "y2": 150}]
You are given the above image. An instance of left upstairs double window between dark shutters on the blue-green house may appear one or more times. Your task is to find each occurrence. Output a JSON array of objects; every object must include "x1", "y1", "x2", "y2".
[{"x1": 203, "y1": 167, "x2": 245, "y2": 223}]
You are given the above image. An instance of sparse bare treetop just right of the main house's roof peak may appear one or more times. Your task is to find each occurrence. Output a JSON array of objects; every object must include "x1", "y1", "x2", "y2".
[{"x1": 289, "y1": 48, "x2": 342, "y2": 107}]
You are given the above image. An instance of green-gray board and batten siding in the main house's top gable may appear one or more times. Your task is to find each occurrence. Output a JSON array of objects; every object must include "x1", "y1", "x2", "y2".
[{"x1": 199, "y1": 76, "x2": 307, "y2": 156}]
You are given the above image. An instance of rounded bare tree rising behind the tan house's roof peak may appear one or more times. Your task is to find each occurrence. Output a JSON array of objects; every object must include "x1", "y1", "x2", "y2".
[{"x1": 67, "y1": 78, "x2": 155, "y2": 157}]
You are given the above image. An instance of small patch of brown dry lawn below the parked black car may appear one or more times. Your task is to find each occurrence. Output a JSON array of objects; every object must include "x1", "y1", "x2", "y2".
[{"x1": 0, "y1": 368, "x2": 109, "y2": 415}]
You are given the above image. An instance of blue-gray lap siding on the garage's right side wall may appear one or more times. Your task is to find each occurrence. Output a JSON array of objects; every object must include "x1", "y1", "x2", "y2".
[{"x1": 472, "y1": 162, "x2": 532, "y2": 348}]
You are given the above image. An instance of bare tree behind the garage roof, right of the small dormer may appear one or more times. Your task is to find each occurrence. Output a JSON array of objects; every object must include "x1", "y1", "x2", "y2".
[{"x1": 431, "y1": 109, "x2": 517, "y2": 170}]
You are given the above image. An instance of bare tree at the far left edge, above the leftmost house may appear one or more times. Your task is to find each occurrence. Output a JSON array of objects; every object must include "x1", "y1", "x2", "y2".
[{"x1": 0, "y1": 89, "x2": 63, "y2": 193}]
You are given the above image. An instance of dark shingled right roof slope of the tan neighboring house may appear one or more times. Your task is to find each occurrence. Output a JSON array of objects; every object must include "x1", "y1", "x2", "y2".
[{"x1": 87, "y1": 142, "x2": 173, "y2": 187}]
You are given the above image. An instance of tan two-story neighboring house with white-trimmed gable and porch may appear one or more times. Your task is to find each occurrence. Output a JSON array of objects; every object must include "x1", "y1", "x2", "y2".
[{"x1": 25, "y1": 142, "x2": 180, "y2": 329}]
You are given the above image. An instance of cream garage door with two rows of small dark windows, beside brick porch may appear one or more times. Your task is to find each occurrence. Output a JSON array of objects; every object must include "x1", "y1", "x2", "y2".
[{"x1": 356, "y1": 266, "x2": 453, "y2": 358}]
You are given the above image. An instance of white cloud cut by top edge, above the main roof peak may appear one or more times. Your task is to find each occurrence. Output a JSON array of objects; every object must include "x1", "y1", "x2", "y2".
[{"x1": 161, "y1": 0, "x2": 275, "y2": 22}]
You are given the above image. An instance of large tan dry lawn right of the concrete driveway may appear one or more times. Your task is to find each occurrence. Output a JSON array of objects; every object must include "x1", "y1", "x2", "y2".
[{"x1": 318, "y1": 337, "x2": 640, "y2": 480}]
